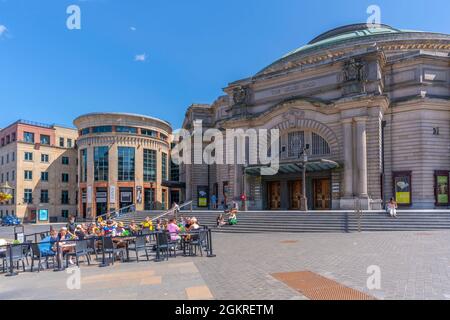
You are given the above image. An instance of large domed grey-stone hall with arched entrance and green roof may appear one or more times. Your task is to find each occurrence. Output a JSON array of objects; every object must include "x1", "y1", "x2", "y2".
[{"x1": 180, "y1": 24, "x2": 450, "y2": 210}]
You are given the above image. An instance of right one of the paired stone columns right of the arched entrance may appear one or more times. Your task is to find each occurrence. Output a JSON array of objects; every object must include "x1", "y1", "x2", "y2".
[{"x1": 355, "y1": 117, "x2": 368, "y2": 198}]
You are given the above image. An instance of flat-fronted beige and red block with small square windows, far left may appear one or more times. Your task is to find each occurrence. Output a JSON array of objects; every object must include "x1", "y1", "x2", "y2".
[{"x1": 0, "y1": 120, "x2": 78, "y2": 222}]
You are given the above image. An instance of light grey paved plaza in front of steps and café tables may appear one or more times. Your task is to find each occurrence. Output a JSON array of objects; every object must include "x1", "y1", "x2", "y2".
[{"x1": 0, "y1": 226, "x2": 450, "y2": 300}]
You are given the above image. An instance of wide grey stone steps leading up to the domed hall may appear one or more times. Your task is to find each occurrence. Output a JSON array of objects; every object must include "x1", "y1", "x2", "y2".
[{"x1": 114, "y1": 210, "x2": 450, "y2": 233}]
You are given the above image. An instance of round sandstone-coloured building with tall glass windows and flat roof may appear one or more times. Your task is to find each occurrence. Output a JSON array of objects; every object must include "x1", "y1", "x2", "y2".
[{"x1": 74, "y1": 113, "x2": 181, "y2": 218}]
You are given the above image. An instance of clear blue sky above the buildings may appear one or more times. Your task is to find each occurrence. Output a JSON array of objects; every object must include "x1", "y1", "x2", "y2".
[{"x1": 0, "y1": 0, "x2": 450, "y2": 128}]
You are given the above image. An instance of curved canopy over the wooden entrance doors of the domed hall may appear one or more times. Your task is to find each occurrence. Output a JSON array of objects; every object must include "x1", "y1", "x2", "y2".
[{"x1": 245, "y1": 159, "x2": 339, "y2": 176}]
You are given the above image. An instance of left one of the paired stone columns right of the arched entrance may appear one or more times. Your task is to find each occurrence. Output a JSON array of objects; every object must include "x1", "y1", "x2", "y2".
[{"x1": 342, "y1": 118, "x2": 353, "y2": 198}]
